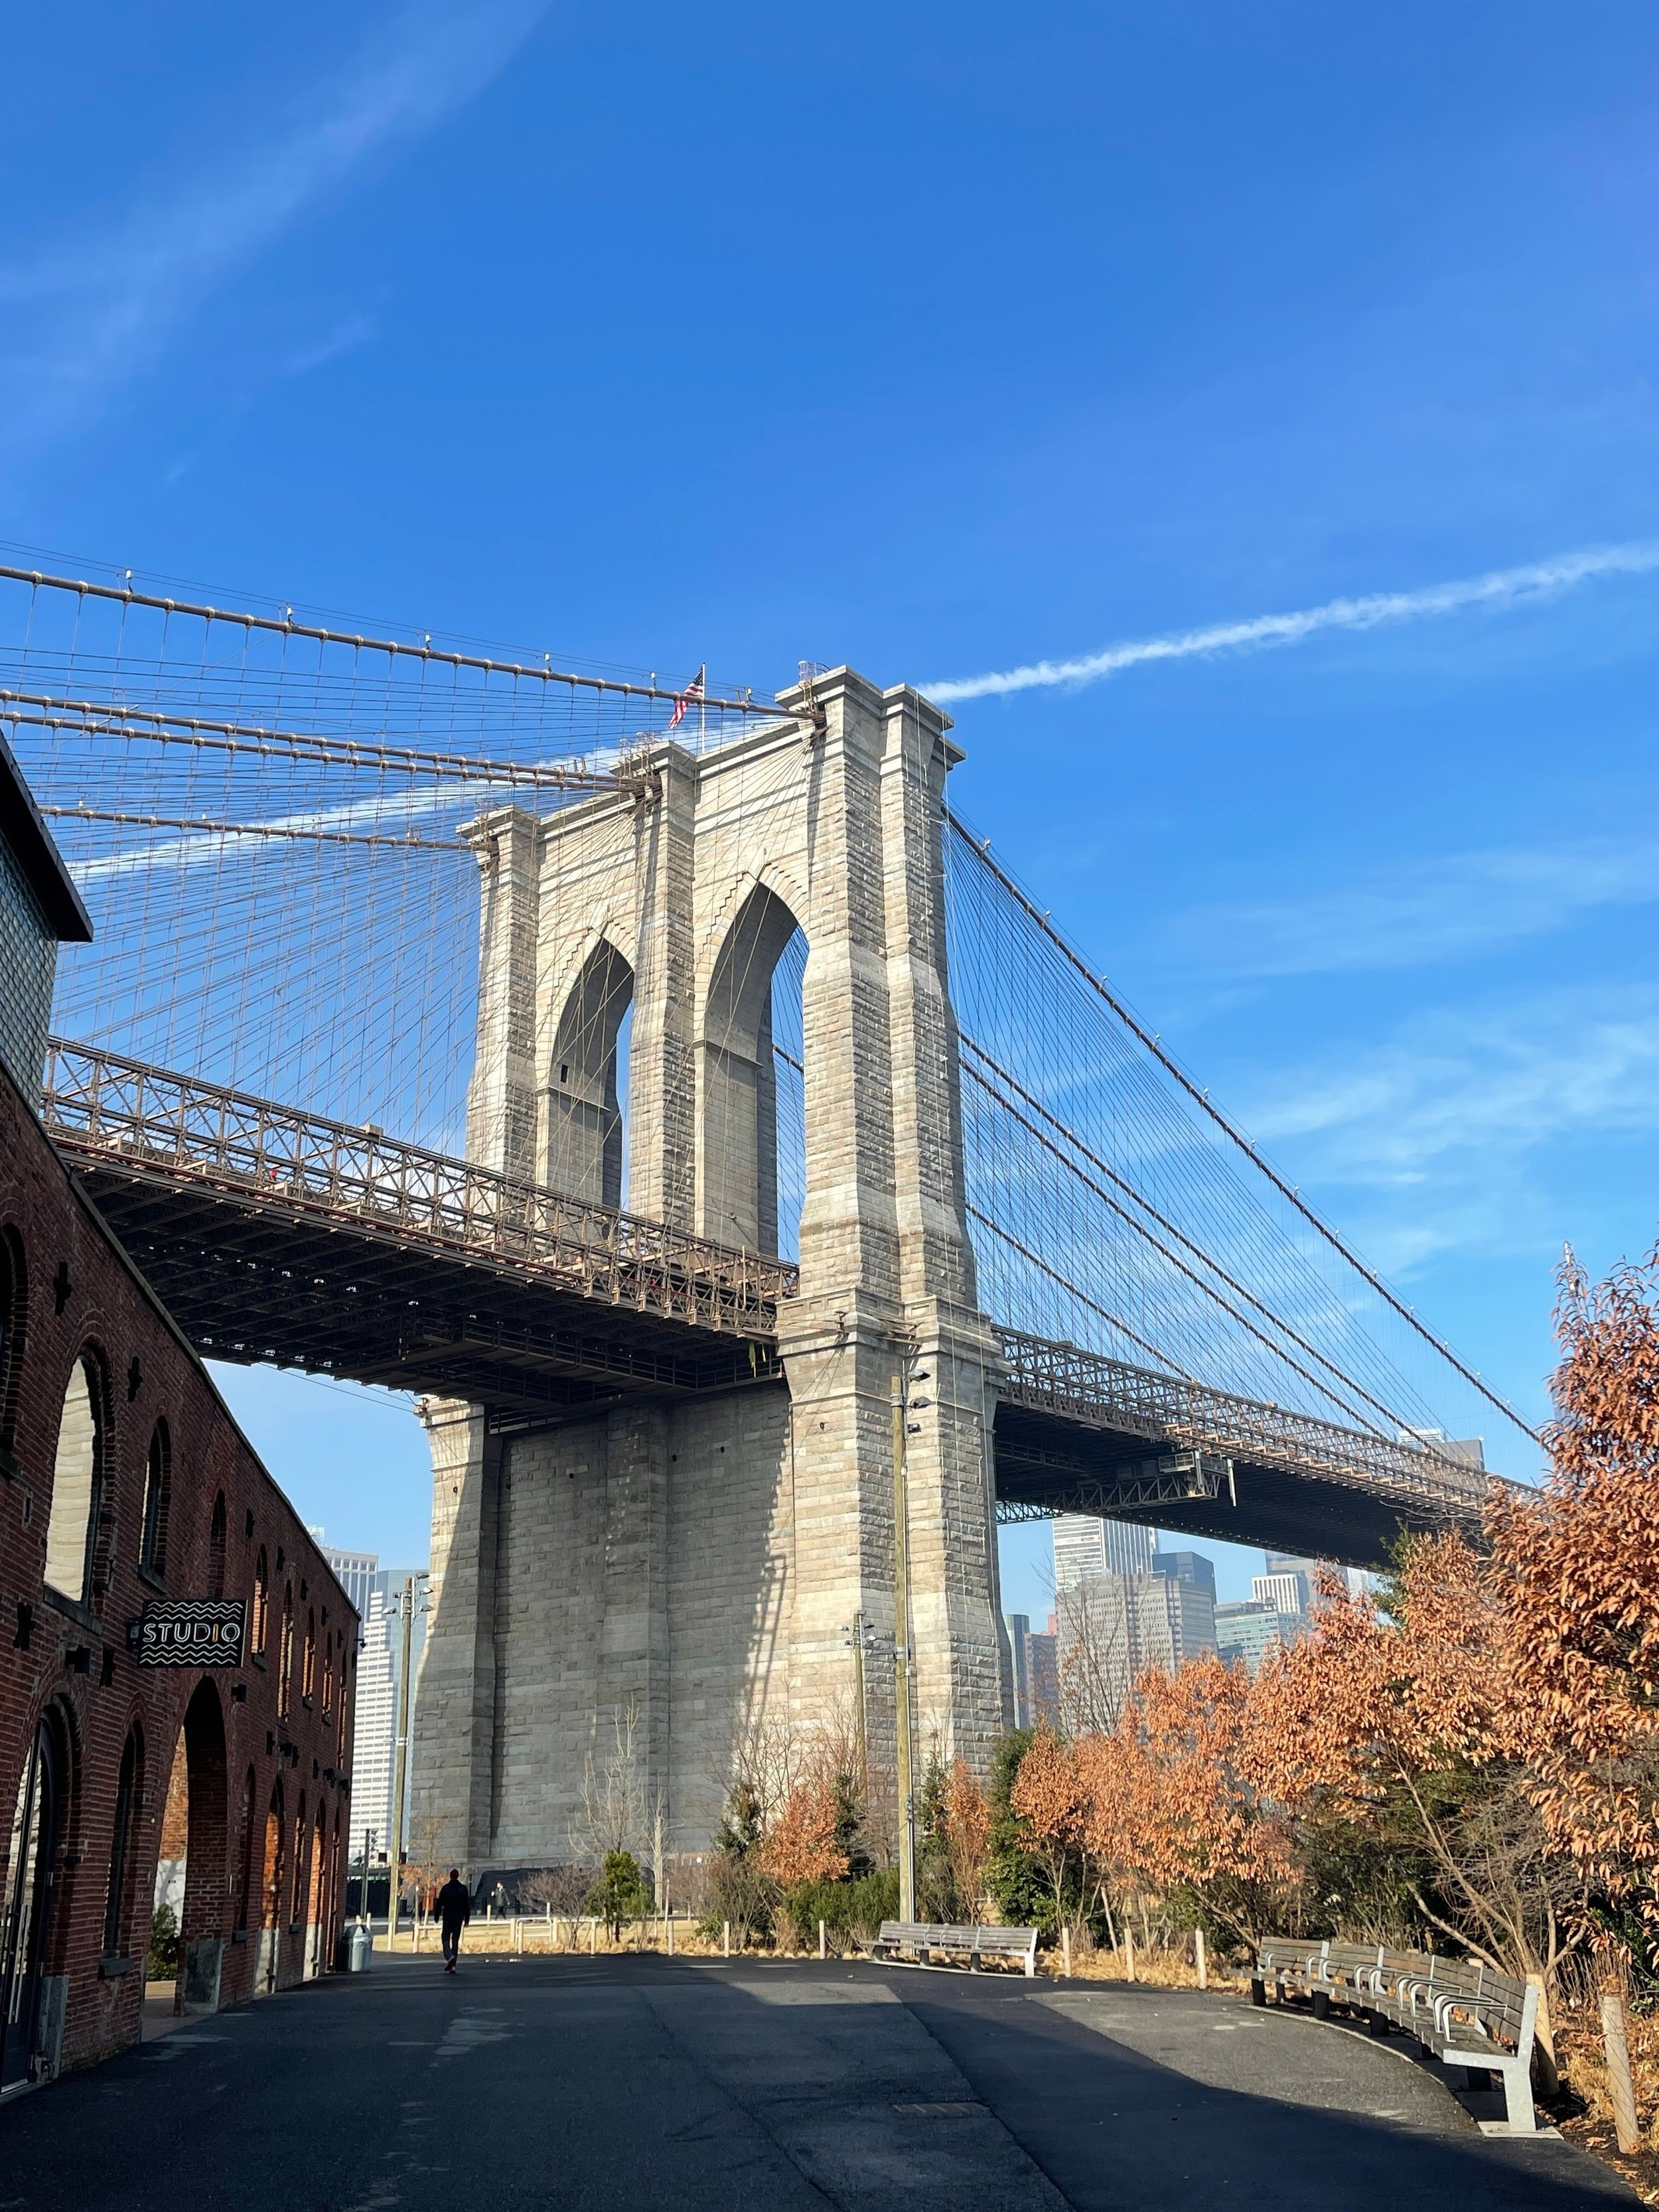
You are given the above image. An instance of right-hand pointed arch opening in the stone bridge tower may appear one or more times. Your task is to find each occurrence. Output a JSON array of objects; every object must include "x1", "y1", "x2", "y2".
[{"x1": 697, "y1": 885, "x2": 805, "y2": 1252}]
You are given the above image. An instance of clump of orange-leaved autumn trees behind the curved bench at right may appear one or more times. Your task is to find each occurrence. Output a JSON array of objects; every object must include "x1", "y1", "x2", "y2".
[{"x1": 1009, "y1": 1254, "x2": 1659, "y2": 1973}]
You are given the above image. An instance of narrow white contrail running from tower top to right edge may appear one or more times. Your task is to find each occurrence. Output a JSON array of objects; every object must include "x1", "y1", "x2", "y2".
[{"x1": 922, "y1": 538, "x2": 1659, "y2": 705}]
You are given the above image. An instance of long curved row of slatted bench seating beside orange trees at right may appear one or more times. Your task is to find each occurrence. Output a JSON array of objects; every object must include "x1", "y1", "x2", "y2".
[{"x1": 1250, "y1": 1935, "x2": 1538, "y2": 2134}]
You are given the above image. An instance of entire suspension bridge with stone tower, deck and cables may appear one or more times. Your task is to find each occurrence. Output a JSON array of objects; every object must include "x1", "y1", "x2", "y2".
[{"x1": 0, "y1": 569, "x2": 1535, "y2": 1862}]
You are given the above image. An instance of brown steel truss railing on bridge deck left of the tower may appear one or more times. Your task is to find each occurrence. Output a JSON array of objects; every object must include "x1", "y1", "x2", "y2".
[{"x1": 42, "y1": 1037, "x2": 798, "y2": 1341}]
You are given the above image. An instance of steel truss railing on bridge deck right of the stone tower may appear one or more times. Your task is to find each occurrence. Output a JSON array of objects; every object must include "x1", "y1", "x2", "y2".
[{"x1": 997, "y1": 1329, "x2": 1495, "y2": 1513}]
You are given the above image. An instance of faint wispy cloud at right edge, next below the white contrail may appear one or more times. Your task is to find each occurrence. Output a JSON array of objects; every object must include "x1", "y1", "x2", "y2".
[{"x1": 1170, "y1": 838, "x2": 1659, "y2": 976}]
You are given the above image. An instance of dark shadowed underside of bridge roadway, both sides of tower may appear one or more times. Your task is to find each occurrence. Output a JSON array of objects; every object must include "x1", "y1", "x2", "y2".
[{"x1": 75, "y1": 1157, "x2": 1438, "y2": 1568}]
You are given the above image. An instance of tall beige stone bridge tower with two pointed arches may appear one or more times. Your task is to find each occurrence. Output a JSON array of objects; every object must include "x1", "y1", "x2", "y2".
[{"x1": 416, "y1": 668, "x2": 1004, "y2": 1872}]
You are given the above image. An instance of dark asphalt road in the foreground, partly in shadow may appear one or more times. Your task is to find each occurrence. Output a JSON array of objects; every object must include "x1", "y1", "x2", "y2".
[{"x1": 0, "y1": 1958, "x2": 1637, "y2": 2212}]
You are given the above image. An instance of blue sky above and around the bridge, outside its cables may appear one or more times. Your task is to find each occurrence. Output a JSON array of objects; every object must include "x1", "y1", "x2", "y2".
[{"x1": 0, "y1": 0, "x2": 1659, "y2": 1610}]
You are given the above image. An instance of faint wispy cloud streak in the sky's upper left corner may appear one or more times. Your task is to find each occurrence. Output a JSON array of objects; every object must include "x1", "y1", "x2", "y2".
[{"x1": 0, "y1": 0, "x2": 546, "y2": 458}]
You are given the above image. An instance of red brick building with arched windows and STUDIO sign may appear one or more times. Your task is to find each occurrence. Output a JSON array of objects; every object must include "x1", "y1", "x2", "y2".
[{"x1": 0, "y1": 1053, "x2": 356, "y2": 2093}]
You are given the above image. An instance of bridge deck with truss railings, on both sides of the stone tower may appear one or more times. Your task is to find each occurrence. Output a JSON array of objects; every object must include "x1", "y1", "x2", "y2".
[{"x1": 44, "y1": 1044, "x2": 1488, "y2": 1564}]
